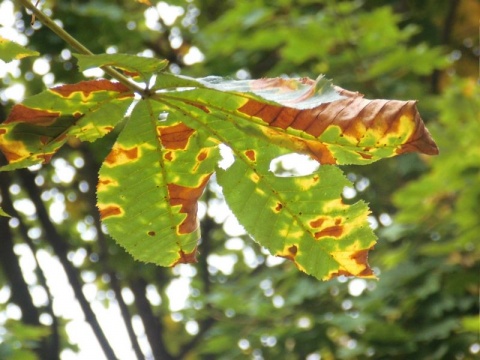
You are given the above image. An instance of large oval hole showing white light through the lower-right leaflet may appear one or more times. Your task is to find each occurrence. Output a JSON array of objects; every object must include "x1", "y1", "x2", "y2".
[{"x1": 270, "y1": 154, "x2": 320, "y2": 177}]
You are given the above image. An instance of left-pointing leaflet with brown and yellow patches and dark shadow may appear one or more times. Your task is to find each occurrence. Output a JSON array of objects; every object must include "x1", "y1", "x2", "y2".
[{"x1": 0, "y1": 80, "x2": 133, "y2": 171}]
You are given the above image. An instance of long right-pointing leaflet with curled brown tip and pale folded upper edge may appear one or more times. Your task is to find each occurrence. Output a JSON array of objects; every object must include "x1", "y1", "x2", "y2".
[{"x1": 155, "y1": 78, "x2": 438, "y2": 165}]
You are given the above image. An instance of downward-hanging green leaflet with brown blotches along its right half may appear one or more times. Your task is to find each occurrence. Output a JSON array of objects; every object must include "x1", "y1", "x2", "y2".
[{"x1": 97, "y1": 100, "x2": 218, "y2": 266}]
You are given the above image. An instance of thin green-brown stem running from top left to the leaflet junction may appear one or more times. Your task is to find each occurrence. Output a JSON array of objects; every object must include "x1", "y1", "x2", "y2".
[{"x1": 18, "y1": 0, "x2": 146, "y2": 95}]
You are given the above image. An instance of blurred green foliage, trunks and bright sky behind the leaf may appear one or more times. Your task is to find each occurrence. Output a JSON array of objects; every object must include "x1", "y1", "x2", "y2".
[{"x1": 0, "y1": 0, "x2": 480, "y2": 360}]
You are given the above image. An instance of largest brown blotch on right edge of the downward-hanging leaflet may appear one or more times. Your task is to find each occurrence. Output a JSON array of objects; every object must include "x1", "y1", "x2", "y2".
[{"x1": 168, "y1": 174, "x2": 211, "y2": 234}]
